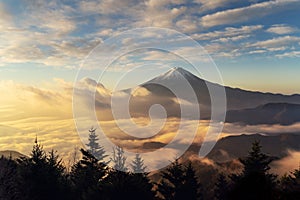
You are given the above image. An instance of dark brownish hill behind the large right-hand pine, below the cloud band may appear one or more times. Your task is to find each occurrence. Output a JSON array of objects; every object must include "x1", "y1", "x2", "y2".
[{"x1": 207, "y1": 133, "x2": 300, "y2": 162}]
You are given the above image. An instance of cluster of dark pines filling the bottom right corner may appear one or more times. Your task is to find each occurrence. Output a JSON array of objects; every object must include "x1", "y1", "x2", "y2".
[{"x1": 215, "y1": 141, "x2": 300, "y2": 200}]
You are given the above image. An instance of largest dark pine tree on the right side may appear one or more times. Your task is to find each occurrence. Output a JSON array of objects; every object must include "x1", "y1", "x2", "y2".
[{"x1": 230, "y1": 141, "x2": 276, "y2": 200}]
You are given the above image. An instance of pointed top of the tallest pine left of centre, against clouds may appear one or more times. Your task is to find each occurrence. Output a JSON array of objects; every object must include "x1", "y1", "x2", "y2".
[{"x1": 86, "y1": 128, "x2": 107, "y2": 161}]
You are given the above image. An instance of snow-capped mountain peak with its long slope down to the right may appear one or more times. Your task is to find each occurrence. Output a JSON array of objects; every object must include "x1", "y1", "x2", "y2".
[{"x1": 140, "y1": 68, "x2": 300, "y2": 119}]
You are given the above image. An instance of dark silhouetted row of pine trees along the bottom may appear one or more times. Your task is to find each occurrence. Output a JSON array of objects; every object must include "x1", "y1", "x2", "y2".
[{"x1": 0, "y1": 129, "x2": 300, "y2": 200}]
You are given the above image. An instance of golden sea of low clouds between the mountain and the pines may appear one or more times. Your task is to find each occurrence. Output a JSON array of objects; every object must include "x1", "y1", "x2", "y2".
[{"x1": 0, "y1": 78, "x2": 300, "y2": 168}]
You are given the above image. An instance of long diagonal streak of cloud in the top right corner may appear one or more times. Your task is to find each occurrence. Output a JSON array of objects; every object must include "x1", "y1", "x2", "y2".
[{"x1": 200, "y1": 0, "x2": 300, "y2": 27}]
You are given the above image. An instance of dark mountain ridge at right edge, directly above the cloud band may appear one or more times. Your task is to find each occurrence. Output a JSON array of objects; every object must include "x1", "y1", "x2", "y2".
[{"x1": 226, "y1": 103, "x2": 300, "y2": 125}]
